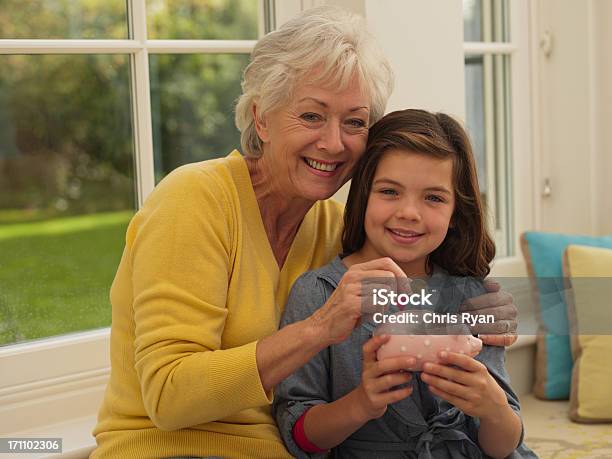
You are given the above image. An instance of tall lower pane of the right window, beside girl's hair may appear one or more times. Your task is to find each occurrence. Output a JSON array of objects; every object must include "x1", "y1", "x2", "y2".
[{"x1": 465, "y1": 55, "x2": 514, "y2": 256}]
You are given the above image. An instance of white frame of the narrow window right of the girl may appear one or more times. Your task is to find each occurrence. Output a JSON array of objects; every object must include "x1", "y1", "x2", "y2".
[{"x1": 463, "y1": 0, "x2": 536, "y2": 277}]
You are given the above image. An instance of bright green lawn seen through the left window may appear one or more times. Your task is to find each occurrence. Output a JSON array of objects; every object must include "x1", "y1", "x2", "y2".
[{"x1": 0, "y1": 212, "x2": 132, "y2": 344}]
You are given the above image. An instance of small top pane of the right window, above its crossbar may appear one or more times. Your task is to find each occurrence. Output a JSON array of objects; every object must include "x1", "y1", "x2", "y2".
[{"x1": 463, "y1": 0, "x2": 510, "y2": 42}]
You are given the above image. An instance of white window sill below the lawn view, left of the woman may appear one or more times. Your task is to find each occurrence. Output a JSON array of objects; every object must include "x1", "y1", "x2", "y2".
[{"x1": 0, "y1": 329, "x2": 110, "y2": 437}]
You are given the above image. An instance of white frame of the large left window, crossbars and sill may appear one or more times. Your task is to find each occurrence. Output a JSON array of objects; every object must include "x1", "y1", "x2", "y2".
[{"x1": 0, "y1": 0, "x2": 262, "y2": 442}]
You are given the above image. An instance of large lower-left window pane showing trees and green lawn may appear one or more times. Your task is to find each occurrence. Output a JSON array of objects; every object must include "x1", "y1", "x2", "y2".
[{"x1": 0, "y1": 55, "x2": 135, "y2": 344}]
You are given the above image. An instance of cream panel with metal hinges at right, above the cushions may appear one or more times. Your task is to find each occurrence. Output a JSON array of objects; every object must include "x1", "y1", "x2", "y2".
[{"x1": 534, "y1": 0, "x2": 612, "y2": 234}]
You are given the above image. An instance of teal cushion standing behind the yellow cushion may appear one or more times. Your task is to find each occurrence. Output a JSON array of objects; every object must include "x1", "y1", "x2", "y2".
[{"x1": 521, "y1": 231, "x2": 612, "y2": 399}]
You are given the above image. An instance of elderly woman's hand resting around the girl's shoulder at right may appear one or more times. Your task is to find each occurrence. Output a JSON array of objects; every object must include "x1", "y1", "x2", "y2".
[{"x1": 459, "y1": 280, "x2": 518, "y2": 346}]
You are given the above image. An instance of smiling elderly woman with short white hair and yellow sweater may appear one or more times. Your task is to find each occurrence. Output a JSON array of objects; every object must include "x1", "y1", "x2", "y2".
[{"x1": 92, "y1": 8, "x2": 516, "y2": 458}]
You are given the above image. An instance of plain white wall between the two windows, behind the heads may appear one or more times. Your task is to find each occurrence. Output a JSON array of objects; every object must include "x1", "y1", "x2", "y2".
[{"x1": 326, "y1": 0, "x2": 465, "y2": 202}]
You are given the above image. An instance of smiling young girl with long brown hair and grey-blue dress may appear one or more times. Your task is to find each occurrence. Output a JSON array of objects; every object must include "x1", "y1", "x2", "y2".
[{"x1": 273, "y1": 110, "x2": 536, "y2": 459}]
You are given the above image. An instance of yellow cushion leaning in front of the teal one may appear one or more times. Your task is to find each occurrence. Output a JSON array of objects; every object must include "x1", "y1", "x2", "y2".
[{"x1": 563, "y1": 245, "x2": 612, "y2": 422}]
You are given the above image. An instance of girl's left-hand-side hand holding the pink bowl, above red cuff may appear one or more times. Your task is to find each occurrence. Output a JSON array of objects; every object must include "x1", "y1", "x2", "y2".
[{"x1": 354, "y1": 335, "x2": 416, "y2": 423}]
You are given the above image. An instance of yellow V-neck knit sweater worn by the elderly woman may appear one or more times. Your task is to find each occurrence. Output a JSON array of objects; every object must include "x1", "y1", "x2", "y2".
[{"x1": 91, "y1": 151, "x2": 342, "y2": 458}]
